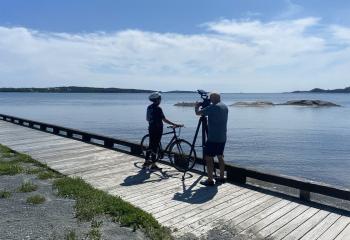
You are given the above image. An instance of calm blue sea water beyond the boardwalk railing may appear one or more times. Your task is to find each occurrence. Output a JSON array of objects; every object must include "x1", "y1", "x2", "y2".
[{"x1": 0, "y1": 93, "x2": 350, "y2": 187}]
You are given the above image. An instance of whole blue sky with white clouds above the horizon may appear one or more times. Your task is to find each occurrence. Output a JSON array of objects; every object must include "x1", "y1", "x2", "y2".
[{"x1": 0, "y1": 0, "x2": 350, "y2": 92}]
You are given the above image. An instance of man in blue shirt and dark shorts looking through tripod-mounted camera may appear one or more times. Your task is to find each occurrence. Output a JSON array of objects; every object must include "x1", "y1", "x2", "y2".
[{"x1": 195, "y1": 92, "x2": 228, "y2": 186}]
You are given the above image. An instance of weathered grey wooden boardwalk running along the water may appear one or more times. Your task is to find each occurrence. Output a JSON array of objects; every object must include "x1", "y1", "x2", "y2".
[{"x1": 0, "y1": 121, "x2": 350, "y2": 240}]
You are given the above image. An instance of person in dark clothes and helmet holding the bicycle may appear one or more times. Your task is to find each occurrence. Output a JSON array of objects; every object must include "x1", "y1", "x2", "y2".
[{"x1": 143, "y1": 92, "x2": 183, "y2": 171}]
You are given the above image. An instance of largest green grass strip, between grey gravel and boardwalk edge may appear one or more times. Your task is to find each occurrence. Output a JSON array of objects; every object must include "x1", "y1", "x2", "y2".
[{"x1": 54, "y1": 177, "x2": 172, "y2": 240}]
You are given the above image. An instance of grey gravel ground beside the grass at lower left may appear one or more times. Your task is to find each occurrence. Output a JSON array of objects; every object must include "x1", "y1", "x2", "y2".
[{"x1": 0, "y1": 174, "x2": 146, "y2": 240}]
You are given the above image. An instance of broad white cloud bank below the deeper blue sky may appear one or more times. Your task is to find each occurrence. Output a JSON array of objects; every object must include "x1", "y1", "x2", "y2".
[{"x1": 0, "y1": 17, "x2": 350, "y2": 92}]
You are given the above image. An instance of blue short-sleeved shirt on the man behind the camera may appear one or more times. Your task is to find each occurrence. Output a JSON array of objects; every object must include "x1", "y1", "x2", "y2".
[{"x1": 202, "y1": 102, "x2": 228, "y2": 143}]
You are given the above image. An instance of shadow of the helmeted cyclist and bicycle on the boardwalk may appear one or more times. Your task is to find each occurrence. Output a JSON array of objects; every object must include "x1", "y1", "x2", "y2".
[{"x1": 120, "y1": 162, "x2": 193, "y2": 187}]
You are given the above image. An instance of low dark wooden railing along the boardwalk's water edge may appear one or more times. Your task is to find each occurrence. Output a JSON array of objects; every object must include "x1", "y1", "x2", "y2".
[{"x1": 0, "y1": 114, "x2": 350, "y2": 201}]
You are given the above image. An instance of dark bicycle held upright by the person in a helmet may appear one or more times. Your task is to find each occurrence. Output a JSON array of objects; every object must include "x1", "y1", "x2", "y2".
[{"x1": 141, "y1": 126, "x2": 197, "y2": 174}]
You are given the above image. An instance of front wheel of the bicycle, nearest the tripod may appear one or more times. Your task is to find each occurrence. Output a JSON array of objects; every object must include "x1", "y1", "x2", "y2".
[{"x1": 169, "y1": 139, "x2": 197, "y2": 172}]
